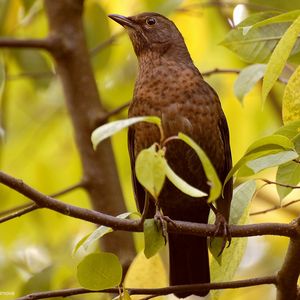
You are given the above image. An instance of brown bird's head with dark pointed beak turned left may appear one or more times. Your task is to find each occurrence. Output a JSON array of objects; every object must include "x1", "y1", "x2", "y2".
[{"x1": 109, "y1": 12, "x2": 190, "y2": 61}]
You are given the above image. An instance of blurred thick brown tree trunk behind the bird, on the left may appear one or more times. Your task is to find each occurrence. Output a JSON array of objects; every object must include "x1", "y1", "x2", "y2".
[{"x1": 45, "y1": 0, "x2": 135, "y2": 265}]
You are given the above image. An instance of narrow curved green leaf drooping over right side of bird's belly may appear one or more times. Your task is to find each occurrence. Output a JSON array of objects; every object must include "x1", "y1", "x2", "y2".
[{"x1": 178, "y1": 132, "x2": 222, "y2": 202}]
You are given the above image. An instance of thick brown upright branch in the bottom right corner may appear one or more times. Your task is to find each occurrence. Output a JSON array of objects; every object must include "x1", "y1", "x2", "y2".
[{"x1": 276, "y1": 220, "x2": 300, "y2": 300}]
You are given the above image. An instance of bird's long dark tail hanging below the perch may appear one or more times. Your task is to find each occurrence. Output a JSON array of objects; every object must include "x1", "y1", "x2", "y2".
[{"x1": 169, "y1": 234, "x2": 210, "y2": 298}]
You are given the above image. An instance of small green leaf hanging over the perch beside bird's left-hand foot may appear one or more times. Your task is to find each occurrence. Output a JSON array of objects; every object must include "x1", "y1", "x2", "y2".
[{"x1": 144, "y1": 219, "x2": 165, "y2": 258}]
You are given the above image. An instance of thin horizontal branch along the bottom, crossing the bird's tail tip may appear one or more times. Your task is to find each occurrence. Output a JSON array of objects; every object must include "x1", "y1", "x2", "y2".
[{"x1": 18, "y1": 276, "x2": 276, "y2": 300}]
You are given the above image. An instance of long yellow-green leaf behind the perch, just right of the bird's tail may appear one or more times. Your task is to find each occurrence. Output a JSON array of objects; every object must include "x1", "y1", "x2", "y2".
[{"x1": 210, "y1": 180, "x2": 256, "y2": 299}]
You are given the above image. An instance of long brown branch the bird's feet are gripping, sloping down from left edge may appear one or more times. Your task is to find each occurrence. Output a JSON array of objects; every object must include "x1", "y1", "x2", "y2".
[{"x1": 0, "y1": 172, "x2": 300, "y2": 238}]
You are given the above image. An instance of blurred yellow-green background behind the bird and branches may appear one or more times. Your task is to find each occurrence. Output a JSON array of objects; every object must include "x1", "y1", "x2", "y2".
[{"x1": 0, "y1": 0, "x2": 300, "y2": 300}]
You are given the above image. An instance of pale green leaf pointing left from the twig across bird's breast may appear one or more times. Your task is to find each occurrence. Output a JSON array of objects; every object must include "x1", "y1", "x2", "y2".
[{"x1": 91, "y1": 116, "x2": 161, "y2": 149}]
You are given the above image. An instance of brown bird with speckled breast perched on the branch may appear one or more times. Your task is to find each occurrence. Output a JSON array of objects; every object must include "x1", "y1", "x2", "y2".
[{"x1": 109, "y1": 12, "x2": 232, "y2": 298}]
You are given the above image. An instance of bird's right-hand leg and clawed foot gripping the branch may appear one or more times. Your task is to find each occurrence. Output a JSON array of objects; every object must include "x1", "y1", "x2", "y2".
[{"x1": 209, "y1": 204, "x2": 231, "y2": 256}]
